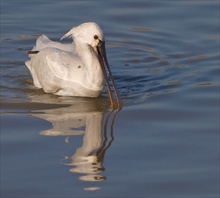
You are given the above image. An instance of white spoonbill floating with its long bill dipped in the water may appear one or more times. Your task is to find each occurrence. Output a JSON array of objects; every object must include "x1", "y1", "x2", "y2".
[{"x1": 25, "y1": 22, "x2": 121, "y2": 109}]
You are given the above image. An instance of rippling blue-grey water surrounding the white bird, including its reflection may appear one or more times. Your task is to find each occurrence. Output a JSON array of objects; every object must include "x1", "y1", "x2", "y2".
[{"x1": 0, "y1": 0, "x2": 220, "y2": 198}]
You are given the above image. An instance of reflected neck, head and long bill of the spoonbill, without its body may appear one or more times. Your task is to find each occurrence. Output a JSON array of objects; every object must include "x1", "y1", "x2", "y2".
[{"x1": 67, "y1": 111, "x2": 118, "y2": 181}]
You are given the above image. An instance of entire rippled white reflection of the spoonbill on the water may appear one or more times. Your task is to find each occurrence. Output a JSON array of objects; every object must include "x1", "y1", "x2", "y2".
[{"x1": 28, "y1": 94, "x2": 119, "y2": 190}]
